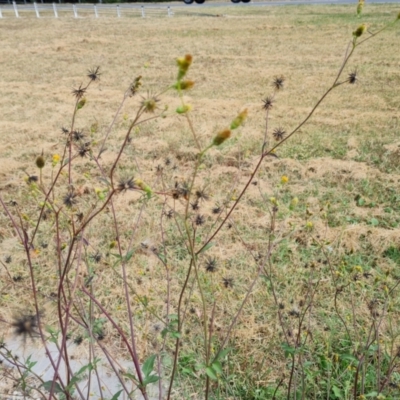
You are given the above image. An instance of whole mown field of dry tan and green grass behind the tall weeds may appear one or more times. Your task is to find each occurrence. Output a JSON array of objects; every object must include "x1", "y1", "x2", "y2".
[{"x1": 0, "y1": 4, "x2": 400, "y2": 399}]
